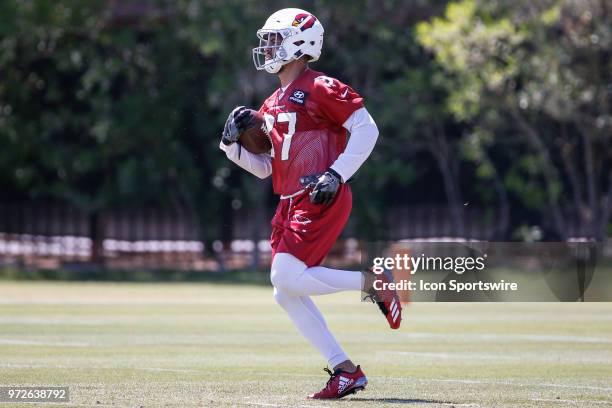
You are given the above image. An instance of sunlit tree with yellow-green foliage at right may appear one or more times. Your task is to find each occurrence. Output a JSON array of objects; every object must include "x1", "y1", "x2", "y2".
[{"x1": 418, "y1": 0, "x2": 612, "y2": 239}]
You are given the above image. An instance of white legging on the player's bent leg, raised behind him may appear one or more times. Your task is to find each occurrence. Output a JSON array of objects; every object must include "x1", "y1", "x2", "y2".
[{"x1": 270, "y1": 253, "x2": 362, "y2": 296}]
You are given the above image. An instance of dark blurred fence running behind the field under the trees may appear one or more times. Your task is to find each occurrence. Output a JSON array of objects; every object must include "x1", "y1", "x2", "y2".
[{"x1": 0, "y1": 202, "x2": 498, "y2": 270}]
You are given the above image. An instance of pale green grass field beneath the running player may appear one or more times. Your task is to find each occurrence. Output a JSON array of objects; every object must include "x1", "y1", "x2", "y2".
[{"x1": 0, "y1": 281, "x2": 612, "y2": 408}]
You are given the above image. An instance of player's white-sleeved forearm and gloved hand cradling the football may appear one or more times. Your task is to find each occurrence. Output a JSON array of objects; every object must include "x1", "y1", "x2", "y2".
[{"x1": 219, "y1": 106, "x2": 272, "y2": 179}]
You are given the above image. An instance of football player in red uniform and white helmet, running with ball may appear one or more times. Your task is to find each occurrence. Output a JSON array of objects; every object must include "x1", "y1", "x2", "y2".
[{"x1": 220, "y1": 8, "x2": 401, "y2": 399}]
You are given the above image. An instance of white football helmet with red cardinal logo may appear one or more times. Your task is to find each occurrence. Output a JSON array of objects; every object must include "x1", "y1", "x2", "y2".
[{"x1": 253, "y1": 8, "x2": 323, "y2": 74}]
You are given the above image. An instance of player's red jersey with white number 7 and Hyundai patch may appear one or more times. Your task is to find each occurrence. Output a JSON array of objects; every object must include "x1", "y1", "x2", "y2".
[{"x1": 259, "y1": 68, "x2": 363, "y2": 195}]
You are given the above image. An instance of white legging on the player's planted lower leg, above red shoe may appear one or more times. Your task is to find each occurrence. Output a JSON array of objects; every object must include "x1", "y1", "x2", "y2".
[{"x1": 274, "y1": 288, "x2": 348, "y2": 368}]
